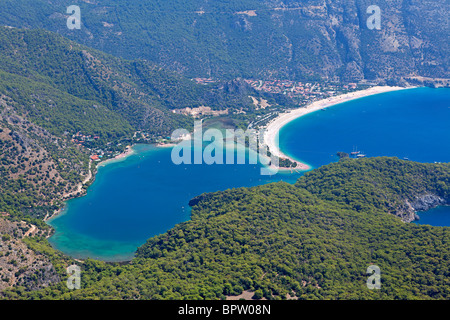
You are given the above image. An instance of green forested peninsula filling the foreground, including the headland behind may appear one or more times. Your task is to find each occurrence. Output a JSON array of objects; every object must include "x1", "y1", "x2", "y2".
[{"x1": 3, "y1": 158, "x2": 450, "y2": 299}]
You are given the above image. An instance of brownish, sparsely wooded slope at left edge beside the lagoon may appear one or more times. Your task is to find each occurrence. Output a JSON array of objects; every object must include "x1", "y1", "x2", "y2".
[{"x1": 0, "y1": 90, "x2": 89, "y2": 219}]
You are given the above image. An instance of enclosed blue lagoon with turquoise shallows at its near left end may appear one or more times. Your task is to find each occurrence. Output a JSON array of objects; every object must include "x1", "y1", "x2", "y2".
[{"x1": 49, "y1": 145, "x2": 299, "y2": 261}]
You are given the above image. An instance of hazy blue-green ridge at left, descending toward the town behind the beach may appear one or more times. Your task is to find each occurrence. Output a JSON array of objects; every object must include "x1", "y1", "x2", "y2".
[{"x1": 0, "y1": 27, "x2": 266, "y2": 136}]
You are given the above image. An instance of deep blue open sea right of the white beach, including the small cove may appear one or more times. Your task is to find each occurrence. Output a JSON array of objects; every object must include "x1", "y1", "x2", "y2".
[{"x1": 279, "y1": 88, "x2": 450, "y2": 226}]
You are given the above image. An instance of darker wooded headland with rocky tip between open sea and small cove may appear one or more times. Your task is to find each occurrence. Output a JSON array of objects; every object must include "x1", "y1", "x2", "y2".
[{"x1": 296, "y1": 158, "x2": 450, "y2": 222}]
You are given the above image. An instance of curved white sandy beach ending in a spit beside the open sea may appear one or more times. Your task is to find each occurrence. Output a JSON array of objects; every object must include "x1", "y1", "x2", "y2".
[{"x1": 264, "y1": 86, "x2": 409, "y2": 171}]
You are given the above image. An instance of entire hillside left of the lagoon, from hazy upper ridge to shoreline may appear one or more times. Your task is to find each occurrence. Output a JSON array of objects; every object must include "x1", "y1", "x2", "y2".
[{"x1": 0, "y1": 27, "x2": 264, "y2": 218}]
